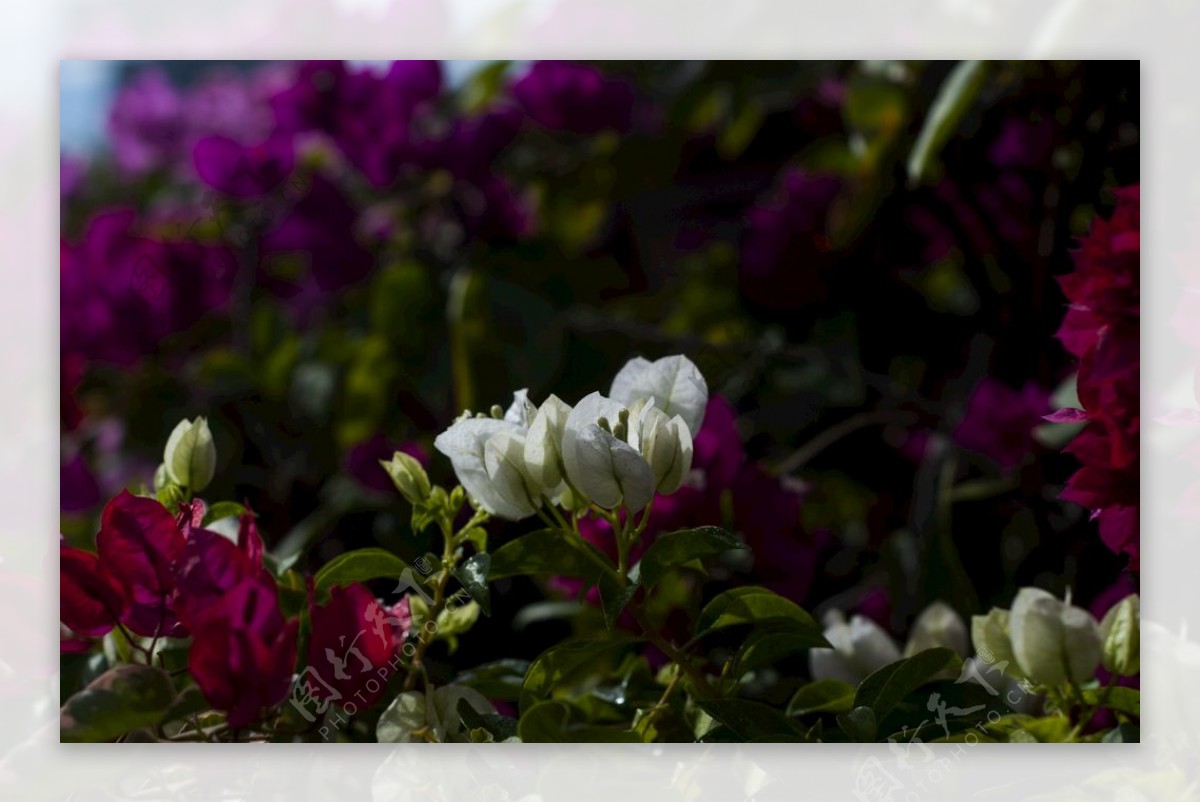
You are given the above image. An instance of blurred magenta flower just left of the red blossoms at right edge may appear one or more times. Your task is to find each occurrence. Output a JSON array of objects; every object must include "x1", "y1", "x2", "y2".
[{"x1": 954, "y1": 377, "x2": 1050, "y2": 471}]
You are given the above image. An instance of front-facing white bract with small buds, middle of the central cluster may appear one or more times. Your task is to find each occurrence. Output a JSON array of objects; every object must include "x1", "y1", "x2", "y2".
[{"x1": 562, "y1": 392, "x2": 656, "y2": 513}]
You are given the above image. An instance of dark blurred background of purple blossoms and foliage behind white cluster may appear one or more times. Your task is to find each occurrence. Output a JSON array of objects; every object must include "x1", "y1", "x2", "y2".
[{"x1": 61, "y1": 61, "x2": 1140, "y2": 666}]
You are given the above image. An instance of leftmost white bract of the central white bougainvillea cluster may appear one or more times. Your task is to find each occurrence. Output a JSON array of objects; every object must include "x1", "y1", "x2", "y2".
[{"x1": 433, "y1": 390, "x2": 541, "y2": 521}]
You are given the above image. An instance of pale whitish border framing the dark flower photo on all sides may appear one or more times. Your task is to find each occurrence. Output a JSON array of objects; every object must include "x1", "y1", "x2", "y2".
[{"x1": 0, "y1": 0, "x2": 1200, "y2": 799}]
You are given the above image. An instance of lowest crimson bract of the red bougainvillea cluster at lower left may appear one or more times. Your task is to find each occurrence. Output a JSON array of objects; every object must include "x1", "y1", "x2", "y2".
[{"x1": 187, "y1": 576, "x2": 298, "y2": 727}]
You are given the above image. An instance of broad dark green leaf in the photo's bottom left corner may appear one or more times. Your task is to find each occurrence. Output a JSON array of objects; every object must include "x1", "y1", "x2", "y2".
[{"x1": 59, "y1": 664, "x2": 175, "y2": 742}]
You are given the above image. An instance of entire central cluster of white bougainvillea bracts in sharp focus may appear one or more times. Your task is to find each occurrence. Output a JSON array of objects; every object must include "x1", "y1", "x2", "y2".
[{"x1": 433, "y1": 354, "x2": 708, "y2": 521}]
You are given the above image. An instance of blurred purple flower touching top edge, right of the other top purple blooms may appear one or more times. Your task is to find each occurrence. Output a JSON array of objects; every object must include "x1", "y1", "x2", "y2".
[{"x1": 512, "y1": 61, "x2": 634, "y2": 134}]
